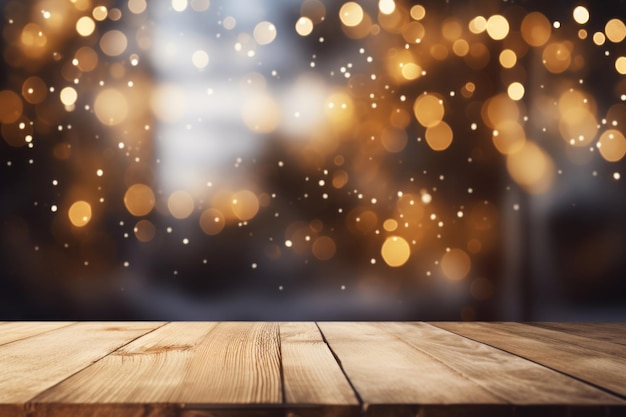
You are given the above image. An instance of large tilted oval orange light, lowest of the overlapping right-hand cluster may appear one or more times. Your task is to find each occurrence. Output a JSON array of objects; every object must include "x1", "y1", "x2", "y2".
[{"x1": 506, "y1": 140, "x2": 555, "y2": 194}]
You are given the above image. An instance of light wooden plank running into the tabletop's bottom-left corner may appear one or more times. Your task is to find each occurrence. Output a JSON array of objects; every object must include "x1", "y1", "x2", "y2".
[{"x1": 0, "y1": 322, "x2": 162, "y2": 417}]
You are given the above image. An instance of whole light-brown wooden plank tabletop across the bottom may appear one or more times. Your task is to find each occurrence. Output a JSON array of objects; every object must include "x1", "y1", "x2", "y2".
[{"x1": 0, "y1": 322, "x2": 626, "y2": 417}]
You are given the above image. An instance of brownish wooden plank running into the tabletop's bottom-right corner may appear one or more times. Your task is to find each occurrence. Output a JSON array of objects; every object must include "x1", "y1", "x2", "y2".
[{"x1": 378, "y1": 323, "x2": 626, "y2": 411}]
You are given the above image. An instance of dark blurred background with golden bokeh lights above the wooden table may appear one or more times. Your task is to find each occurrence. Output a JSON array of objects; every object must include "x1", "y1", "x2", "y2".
[{"x1": 0, "y1": 0, "x2": 626, "y2": 320}]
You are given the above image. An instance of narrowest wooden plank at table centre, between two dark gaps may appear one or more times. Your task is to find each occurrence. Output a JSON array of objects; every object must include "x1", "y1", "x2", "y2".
[{"x1": 280, "y1": 322, "x2": 360, "y2": 416}]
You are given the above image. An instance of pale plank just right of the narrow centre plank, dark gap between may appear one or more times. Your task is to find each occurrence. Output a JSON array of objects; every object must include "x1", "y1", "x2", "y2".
[{"x1": 318, "y1": 322, "x2": 511, "y2": 416}]
